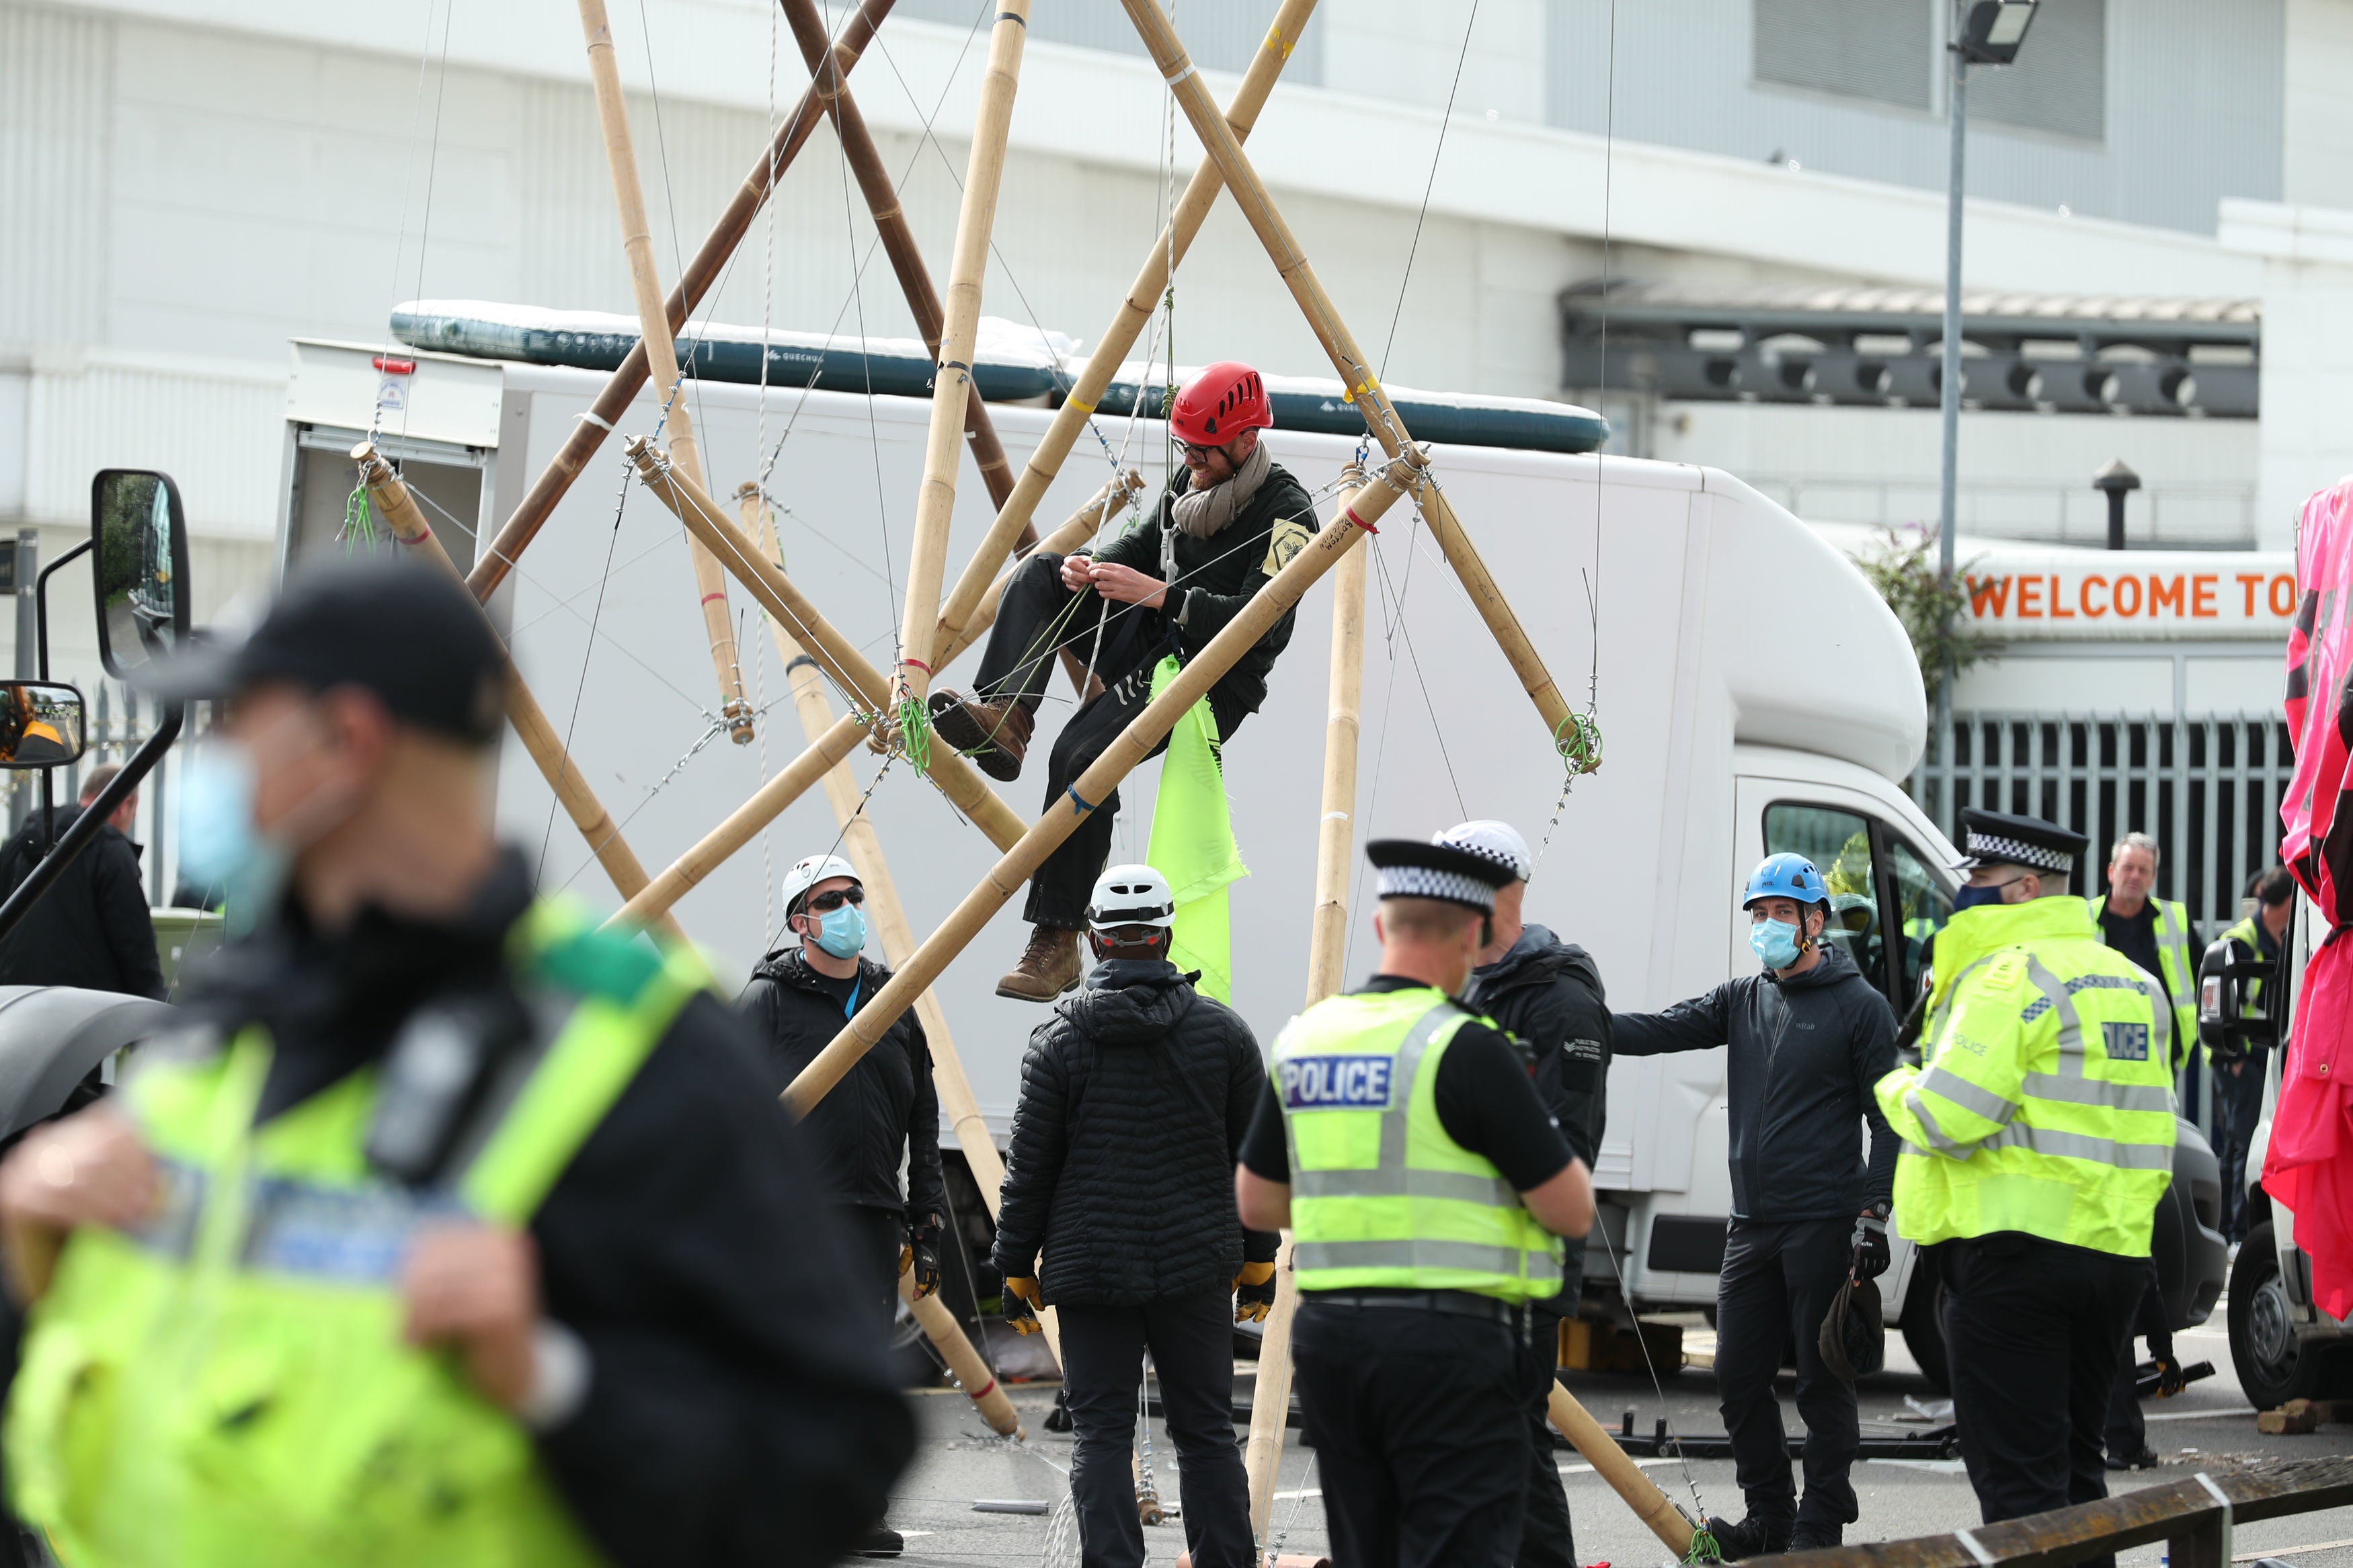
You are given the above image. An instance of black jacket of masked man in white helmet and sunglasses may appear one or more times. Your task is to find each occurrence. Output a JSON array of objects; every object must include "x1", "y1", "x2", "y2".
[{"x1": 737, "y1": 948, "x2": 946, "y2": 1227}]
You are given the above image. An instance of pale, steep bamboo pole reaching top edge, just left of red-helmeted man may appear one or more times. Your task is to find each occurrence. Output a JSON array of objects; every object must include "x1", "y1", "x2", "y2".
[{"x1": 897, "y1": 0, "x2": 1029, "y2": 703}]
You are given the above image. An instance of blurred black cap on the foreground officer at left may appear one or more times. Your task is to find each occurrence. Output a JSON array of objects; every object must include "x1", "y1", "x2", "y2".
[{"x1": 134, "y1": 554, "x2": 506, "y2": 745}]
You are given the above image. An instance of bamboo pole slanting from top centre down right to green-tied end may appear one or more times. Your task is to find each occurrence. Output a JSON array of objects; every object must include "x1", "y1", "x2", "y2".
[{"x1": 1120, "y1": 0, "x2": 1572, "y2": 747}]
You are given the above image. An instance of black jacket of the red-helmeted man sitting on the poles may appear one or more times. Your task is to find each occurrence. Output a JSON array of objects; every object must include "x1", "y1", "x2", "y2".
[{"x1": 1096, "y1": 463, "x2": 1316, "y2": 712}]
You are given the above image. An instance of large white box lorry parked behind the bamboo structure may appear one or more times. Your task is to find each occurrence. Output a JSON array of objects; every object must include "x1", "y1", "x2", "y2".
[{"x1": 280, "y1": 343, "x2": 2221, "y2": 1354}]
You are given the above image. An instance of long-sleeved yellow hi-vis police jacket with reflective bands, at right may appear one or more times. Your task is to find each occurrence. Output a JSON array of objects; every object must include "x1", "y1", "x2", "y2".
[{"x1": 1878, "y1": 898, "x2": 2174, "y2": 1257}]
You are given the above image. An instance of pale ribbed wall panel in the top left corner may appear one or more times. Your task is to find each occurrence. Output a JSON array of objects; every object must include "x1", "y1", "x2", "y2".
[{"x1": 0, "y1": 5, "x2": 116, "y2": 343}]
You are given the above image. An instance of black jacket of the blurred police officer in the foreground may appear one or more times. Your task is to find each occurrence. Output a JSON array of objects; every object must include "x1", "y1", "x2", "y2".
[{"x1": 7, "y1": 854, "x2": 916, "y2": 1568}]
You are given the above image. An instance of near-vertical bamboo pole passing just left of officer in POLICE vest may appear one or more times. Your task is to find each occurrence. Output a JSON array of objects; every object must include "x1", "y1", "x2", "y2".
[{"x1": 1242, "y1": 470, "x2": 1367, "y2": 1547}]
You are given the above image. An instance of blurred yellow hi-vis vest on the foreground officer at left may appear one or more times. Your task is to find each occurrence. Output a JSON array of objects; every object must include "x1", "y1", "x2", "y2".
[{"x1": 5, "y1": 903, "x2": 706, "y2": 1568}]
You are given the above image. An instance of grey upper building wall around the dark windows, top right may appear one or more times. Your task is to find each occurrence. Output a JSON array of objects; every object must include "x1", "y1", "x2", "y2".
[{"x1": 1546, "y1": 0, "x2": 2287, "y2": 233}]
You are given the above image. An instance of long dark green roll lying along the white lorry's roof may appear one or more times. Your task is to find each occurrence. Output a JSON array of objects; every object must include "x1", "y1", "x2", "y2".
[{"x1": 393, "y1": 298, "x2": 1609, "y2": 454}]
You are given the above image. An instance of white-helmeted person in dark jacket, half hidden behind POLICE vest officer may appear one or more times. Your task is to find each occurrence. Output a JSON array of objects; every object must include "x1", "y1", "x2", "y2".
[{"x1": 1438, "y1": 821, "x2": 1609, "y2": 1568}]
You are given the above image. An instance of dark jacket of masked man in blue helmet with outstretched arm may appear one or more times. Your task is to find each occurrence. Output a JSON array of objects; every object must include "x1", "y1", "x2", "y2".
[{"x1": 1609, "y1": 943, "x2": 1897, "y2": 1223}]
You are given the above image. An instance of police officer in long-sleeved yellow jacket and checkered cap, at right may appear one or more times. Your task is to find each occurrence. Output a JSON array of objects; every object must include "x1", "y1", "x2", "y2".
[{"x1": 1878, "y1": 811, "x2": 2174, "y2": 1563}]
